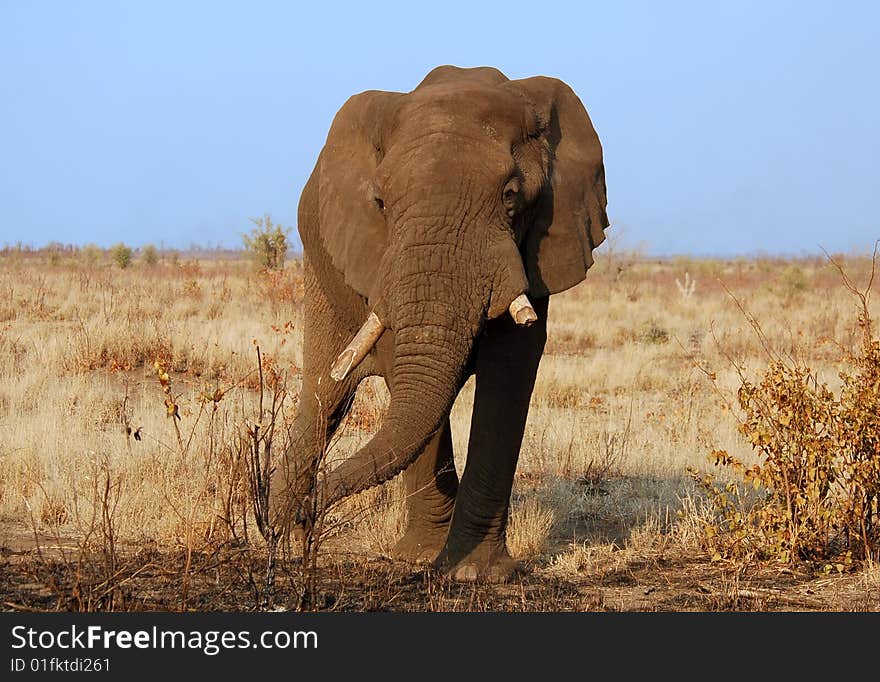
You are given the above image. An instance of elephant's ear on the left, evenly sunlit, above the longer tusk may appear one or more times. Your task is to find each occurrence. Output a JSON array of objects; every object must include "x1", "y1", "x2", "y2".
[{"x1": 316, "y1": 90, "x2": 401, "y2": 297}]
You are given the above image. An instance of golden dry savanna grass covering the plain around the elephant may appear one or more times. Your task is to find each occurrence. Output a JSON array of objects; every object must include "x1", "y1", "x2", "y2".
[{"x1": 0, "y1": 247, "x2": 878, "y2": 609}]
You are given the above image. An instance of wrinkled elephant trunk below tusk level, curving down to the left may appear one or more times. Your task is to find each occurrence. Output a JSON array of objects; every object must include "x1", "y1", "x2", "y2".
[{"x1": 323, "y1": 302, "x2": 479, "y2": 504}]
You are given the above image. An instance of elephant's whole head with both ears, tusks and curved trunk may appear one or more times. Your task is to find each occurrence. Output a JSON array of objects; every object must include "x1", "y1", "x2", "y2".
[{"x1": 299, "y1": 66, "x2": 608, "y2": 501}]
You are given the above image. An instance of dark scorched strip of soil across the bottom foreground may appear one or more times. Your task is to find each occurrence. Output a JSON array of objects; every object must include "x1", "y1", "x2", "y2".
[{"x1": 0, "y1": 524, "x2": 880, "y2": 611}]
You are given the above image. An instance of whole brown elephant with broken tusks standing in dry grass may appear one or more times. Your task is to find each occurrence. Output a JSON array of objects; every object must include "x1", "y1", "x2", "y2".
[{"x1": 272, "y1": 66, "x2": 608, "y2": 581}]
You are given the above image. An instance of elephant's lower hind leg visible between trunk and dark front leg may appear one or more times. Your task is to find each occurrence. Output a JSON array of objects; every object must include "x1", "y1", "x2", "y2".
[{"x1": 393, "y1": 419, "x2": 458, "y2": 563}]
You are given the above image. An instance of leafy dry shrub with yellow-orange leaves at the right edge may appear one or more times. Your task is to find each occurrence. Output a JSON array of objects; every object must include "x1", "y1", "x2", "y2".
[{"x1": 692, "y1": 253, "x2": 880, "y2": 572}]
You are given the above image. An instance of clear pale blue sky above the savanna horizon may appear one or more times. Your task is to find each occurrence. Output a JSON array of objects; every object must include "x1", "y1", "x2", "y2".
[{"x1": 0, "y1": 0, "x2": 880, "y2": 255}]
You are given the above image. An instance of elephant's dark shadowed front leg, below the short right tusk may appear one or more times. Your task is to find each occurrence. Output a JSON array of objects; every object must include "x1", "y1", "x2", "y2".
[{"x1": 436, "y1": 298, "x2": 548, "y2": 582}]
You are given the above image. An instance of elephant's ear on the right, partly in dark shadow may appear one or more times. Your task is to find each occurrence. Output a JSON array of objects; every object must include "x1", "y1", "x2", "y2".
[{"x1": 507, "y1": 76, "x2": 608, "y2": 296}]
